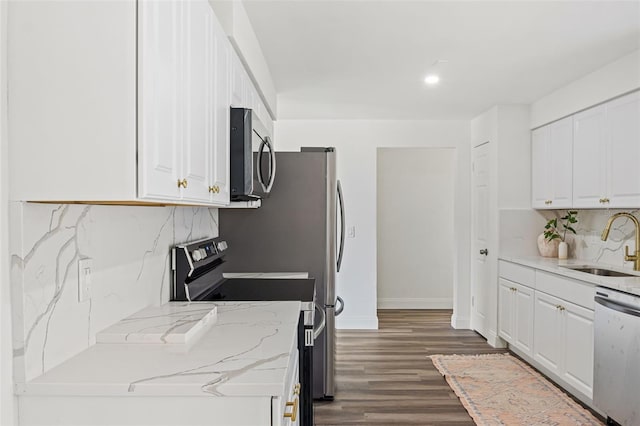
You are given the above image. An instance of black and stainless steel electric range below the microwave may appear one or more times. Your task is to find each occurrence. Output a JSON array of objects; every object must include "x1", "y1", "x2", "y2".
[{"x1": 171, "y1": 238, "x2": 325, "y2": 426}]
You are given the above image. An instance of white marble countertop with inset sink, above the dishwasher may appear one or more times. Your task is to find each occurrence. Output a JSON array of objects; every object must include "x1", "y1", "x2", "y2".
[{"x1": 499, "y1": 256, "x2": 640, "y2": 296}]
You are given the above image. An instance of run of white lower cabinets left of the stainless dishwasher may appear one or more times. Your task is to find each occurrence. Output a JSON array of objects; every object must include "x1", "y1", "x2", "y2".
[{"x1": 498, "y1": 261, "x2": 595, "y2": 403}]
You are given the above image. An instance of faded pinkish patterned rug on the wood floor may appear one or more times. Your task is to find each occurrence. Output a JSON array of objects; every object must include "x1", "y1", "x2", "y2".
[{"x1": 430, "y1": 354, "x2": 603, "y2": 426}]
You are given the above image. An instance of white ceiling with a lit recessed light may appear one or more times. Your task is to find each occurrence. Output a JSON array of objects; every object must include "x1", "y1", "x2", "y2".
[{"x1": 243, "y1": 0, "x2": 640, "y2": 119}]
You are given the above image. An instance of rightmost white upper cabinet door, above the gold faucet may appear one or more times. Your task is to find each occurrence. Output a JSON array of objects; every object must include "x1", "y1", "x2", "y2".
[{"x1": 605, "y1": 92, "x2": 640, "y2": 208}]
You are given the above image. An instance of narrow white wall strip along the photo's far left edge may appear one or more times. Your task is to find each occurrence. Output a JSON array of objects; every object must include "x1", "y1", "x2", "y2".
[{"x1": 0, "y1": 1, "x2": 18, "y2": 425}]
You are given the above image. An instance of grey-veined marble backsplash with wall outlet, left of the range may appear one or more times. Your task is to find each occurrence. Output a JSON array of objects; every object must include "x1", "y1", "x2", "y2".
[{"x1": 10, "y1": 202, "x2": 218, "y2": 383}]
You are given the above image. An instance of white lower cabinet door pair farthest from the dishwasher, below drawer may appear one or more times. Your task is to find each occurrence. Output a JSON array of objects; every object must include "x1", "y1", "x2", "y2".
[{"x1": 498, "y1": 278, "x2": 534, "y2": 356}]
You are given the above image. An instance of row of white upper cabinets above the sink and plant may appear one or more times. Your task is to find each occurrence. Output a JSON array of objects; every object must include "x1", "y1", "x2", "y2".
[{"x1": 531, "y1": 92, "x2": 640, "y2": 209}]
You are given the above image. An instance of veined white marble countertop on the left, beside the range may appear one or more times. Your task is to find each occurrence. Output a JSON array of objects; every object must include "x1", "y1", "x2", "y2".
[{"x1": 15, "y1": 301, "x2": 300, "y2": 396}]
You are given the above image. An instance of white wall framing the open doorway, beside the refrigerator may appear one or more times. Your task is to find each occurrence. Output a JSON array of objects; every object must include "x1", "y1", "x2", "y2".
[{"x1": 274, "y1": 120, "x2": 470, "y2": 328}]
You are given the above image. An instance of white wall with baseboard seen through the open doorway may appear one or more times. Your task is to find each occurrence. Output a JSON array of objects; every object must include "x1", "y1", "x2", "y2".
[{"x1": 377, "y1": 148, "x2": 455, "y2": 309}]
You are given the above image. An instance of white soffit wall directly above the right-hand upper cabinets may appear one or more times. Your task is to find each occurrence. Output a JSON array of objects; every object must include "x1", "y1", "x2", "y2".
[{"x1": 531, "y1": 50, "x2": 640, "y2": 128}]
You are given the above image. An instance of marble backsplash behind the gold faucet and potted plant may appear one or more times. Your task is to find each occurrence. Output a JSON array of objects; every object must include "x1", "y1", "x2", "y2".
[{"x1": 499, "y1": 209, "x2": 640, "y2": 268}]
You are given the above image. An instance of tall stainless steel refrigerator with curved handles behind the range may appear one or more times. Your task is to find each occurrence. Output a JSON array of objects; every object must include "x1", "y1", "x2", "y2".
[{"x1": 219, "y1": 148, "x2": 345, "y2": 400}]
